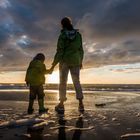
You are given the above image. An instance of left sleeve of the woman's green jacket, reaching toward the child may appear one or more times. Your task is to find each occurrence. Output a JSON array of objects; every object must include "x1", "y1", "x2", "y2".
[{"x1": 52, "y1": 35, "x2": 65, "y2": 66}]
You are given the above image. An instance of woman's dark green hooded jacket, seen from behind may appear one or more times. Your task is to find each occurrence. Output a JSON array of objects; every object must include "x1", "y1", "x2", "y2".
[{"x1": 52, "y1": 29, "x2": 84, "y2": 66}]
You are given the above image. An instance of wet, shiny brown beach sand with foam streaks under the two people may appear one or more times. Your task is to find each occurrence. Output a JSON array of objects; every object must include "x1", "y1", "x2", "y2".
[{"x1": 0, "y1": 91, "x2": 140, "y2": 140}]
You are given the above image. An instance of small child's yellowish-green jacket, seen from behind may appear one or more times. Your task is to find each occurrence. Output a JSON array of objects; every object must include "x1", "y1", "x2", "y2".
[{"x1": 25, "y1": 60, "x2": 46, "y2": 86}]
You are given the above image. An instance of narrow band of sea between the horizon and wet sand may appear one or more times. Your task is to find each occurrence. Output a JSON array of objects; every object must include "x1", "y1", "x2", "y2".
[{"x1": 0, "y1": 83, "x2": 140, "y2": 93}]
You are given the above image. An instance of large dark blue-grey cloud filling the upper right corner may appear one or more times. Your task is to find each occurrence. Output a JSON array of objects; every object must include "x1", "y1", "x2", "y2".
[{"x1": 78, "y1": 0, "x2": 140, "y2": 39}]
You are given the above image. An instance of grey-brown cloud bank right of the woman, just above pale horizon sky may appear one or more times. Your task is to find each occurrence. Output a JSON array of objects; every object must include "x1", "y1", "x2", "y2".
[{"x1": 85, "y1": 40, "x2": 140, "y2": 67}]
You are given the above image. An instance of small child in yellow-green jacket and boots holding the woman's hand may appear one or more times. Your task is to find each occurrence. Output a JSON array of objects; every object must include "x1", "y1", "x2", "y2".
[{"x1": 25, "y1": 53, "x2": 49, "y2": 114}]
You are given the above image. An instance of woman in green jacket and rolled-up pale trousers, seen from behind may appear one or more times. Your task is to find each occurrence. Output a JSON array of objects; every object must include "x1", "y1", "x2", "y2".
[{"x1": 50, "y1": 17, "x2": 84, "y2": 112}]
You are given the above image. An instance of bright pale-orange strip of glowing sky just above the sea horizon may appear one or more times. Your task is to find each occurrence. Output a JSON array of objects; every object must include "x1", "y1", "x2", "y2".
[{"x1": 0, "y1": 66, "x2": 140, "y2": 84}]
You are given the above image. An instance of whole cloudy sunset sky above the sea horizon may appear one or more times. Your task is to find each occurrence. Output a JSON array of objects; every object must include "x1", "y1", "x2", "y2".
[{"x1": 0, "y1": 0, "x2": 140, "y2": 84}]
